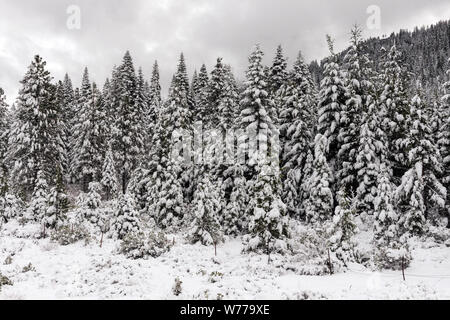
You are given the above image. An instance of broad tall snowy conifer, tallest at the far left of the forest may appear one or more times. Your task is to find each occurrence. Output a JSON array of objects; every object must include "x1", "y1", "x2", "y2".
[{"x1": 7, "y1": 56, "x2": 61, "y2": 197}]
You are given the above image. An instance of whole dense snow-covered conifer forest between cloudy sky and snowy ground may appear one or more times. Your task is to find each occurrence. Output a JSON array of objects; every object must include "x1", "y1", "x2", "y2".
[{"x1": 0, "y1": 22, "x2": 450, "y2": 298}]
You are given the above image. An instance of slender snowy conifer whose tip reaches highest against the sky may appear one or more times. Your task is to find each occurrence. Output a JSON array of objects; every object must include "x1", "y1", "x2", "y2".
[{"x1": 337, "y1": 26, "x2": 374, "y2": 194}]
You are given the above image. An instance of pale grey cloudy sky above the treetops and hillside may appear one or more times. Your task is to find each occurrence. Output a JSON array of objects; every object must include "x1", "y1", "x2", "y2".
[{"x1": 0, "y1": 0, "x2": 450, "y2": 102}]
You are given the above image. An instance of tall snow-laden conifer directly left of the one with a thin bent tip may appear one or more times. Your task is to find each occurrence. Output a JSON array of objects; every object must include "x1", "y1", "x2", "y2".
[{"x1": 277, "y1": 53, "x2": 316, "y2": 216}]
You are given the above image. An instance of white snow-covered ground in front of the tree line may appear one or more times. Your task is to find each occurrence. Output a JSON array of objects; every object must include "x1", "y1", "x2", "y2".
[{"x1": 0, "y1": 220, "x2": 450, "y2": 299}]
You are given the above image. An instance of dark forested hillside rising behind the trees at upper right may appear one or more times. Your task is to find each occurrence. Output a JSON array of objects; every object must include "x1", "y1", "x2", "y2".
[{"x1": 310, "y1": 20, "x2": 450, "y2": 97}]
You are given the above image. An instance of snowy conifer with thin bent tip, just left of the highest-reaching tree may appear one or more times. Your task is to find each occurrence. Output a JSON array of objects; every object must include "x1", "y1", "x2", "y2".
[{"x1": 317, "y1": 36, "x2": 347, "y2": 162}]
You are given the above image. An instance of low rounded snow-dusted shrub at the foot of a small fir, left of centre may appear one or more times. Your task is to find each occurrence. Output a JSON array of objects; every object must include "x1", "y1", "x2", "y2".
[{"x1": 119, "y1": 231, "x2": 171, "y2": 259}]
